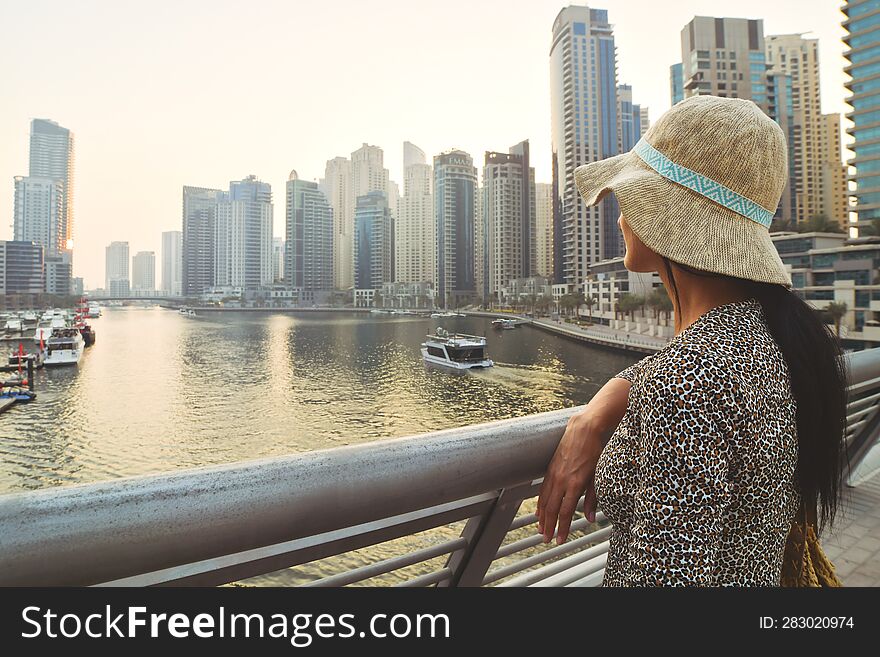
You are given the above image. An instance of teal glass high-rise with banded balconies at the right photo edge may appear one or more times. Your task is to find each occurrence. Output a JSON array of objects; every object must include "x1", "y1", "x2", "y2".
[{"x1": 841, "y1": 0, "x2": 880, "y2": 226}]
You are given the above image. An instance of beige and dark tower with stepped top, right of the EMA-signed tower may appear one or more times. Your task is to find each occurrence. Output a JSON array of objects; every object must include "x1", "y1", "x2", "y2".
[{"x1": 477, "y1": 140, "x2": 536, "y2": 298}]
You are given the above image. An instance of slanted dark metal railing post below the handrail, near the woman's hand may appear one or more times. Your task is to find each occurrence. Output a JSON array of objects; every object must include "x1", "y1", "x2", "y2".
[{"x1": 437, "y1": 482, "x2": 532, "y2": 586}]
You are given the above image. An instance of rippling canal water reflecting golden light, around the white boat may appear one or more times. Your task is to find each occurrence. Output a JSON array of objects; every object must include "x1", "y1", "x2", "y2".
[{"x1": 0, "y1": 307, "x2": 637, "y2": 581}]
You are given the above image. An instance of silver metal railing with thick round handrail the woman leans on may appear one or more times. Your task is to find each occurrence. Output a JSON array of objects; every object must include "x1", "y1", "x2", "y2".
[{"x1": 0, "y1": 348, "x2": 880, "y2": 586}]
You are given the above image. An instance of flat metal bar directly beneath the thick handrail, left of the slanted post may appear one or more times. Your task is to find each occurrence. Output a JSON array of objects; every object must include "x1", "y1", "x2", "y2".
[{"x1": 103, "y1": 493, "x2": 497, "y2": 586}]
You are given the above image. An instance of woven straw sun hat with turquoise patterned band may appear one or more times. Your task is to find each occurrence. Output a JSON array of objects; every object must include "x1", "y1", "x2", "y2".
[{"x1": 574, "y1": 96, "x2": 792, "y2": 288}]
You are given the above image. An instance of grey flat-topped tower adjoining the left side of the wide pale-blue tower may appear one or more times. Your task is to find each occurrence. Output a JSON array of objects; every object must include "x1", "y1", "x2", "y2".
[{"x1": 181, "y1": 186, "x2": 227, "y2": 297}]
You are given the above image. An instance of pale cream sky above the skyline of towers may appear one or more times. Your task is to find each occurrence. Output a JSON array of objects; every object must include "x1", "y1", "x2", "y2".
[{"x1": 0, "y1": 0, "x2": 847, "y2": 288}]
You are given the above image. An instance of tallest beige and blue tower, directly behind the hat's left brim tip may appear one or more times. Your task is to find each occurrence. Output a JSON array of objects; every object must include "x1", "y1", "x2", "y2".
[{"x1": 550, "y1": 6, "x2": 624, "y2": 284}]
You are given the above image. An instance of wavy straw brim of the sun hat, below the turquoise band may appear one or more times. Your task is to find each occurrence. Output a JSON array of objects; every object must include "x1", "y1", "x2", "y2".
[{"x1": 574, "y1": 151, "x2": 792, "y2": 289}]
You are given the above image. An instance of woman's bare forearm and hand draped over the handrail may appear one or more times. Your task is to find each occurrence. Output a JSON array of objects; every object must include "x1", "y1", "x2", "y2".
[{"x1": 536, "y1": 378, "x2": 630, "y2": 544}]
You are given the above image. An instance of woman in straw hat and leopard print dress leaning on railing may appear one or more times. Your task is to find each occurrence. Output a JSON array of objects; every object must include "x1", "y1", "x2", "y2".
[{"x1": 537, "y1": 96, "x2": 846, "y2": 586}]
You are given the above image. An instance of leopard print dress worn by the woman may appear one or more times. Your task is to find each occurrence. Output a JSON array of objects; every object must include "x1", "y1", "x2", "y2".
[{"x1": 595, "y1": 298, "x2": 800, "y2": 586}]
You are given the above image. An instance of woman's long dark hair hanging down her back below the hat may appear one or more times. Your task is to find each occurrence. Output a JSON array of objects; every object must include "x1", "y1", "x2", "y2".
[{"x1": 663, "y1": 257, "x2": 849, "y2": 532}]
